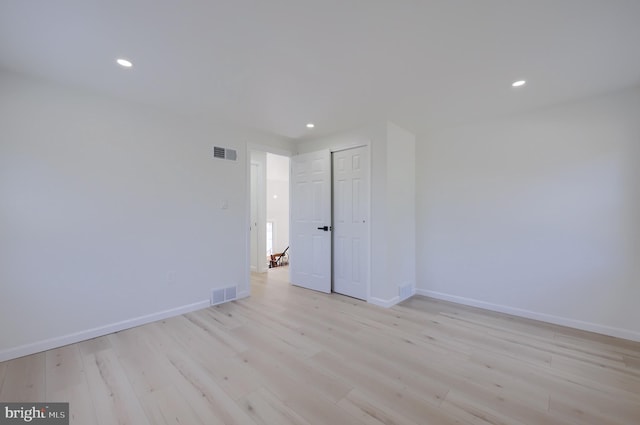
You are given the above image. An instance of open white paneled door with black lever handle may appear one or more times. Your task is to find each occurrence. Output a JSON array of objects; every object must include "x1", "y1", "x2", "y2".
[{"x1": 289, "y1": 150, "x2": 331, "y2": 293}]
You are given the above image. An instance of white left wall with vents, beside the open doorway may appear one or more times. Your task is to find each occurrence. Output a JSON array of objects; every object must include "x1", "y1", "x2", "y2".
[{"x1": 0, "y1": 73, "x2": 291, "y2": 360}]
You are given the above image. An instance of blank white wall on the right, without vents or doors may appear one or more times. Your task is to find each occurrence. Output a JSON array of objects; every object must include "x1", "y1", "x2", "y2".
[{"x1": 416, "y1": 89, "x2": 640, "y2": 339}]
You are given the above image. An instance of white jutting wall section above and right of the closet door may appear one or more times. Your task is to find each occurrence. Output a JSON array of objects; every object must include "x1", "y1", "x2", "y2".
[{"x1": 297, "y1": 122, "x2": 415, "y2": 307}]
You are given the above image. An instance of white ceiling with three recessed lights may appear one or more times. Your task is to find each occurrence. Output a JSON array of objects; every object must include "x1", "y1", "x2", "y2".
[{"x1": 0, "y1": 0, "x2": 640, "y2": 138}]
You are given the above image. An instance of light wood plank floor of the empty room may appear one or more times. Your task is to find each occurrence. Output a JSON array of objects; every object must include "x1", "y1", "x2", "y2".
[{"x1": 0, "y1": 269, "x2": 640, "y2": 425}]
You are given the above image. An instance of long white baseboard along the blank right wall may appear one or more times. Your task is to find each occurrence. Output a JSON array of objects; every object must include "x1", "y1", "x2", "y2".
[{"x1": 416, "y1": 288, "x2": 640, "y2": 341}]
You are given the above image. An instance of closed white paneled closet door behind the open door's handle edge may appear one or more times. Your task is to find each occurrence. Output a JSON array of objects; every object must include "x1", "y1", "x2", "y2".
[{"x1": 333, "y1": 146, "x2": 369, "y2": 300}]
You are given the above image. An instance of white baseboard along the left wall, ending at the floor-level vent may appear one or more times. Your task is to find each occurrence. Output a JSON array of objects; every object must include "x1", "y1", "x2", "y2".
[{"x1": 0, "y1": 300, "x2": 211, "y2": 362}]
